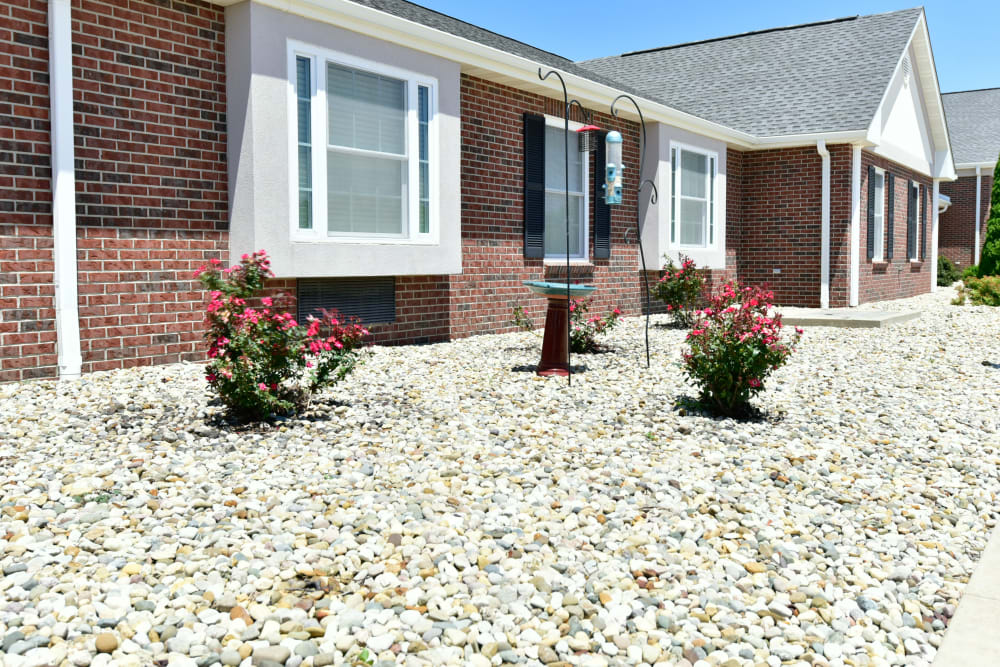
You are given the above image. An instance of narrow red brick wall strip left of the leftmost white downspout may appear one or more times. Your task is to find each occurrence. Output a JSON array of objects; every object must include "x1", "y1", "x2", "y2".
[{"x1": 0, "y1": 0, "x2": 57, "y2": 382}]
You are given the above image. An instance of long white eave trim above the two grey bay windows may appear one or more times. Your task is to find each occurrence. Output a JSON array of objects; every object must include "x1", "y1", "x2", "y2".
[{"x1": 225, "y1": 0, "x2": 756, "y2": 148}]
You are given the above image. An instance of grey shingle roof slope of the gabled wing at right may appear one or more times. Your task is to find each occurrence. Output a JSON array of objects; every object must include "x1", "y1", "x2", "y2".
[{"x1": 580, "y1": 8, "x2": 922, "y2": 137}]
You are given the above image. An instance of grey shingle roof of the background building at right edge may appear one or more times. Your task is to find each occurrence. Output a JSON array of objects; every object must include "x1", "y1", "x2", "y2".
[{"x1": 941, "y1": 88, "x2": 1000, "y2": 164}]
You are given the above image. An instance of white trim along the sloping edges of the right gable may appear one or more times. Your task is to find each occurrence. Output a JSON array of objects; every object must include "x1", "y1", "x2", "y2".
[{"x1": 867, "y1": 9, "x2": 956, "y2": 180}]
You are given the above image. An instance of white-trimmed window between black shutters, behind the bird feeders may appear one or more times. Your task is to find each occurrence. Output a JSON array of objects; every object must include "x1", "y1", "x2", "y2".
[{"x1": 545, "y1": 118, "x2": 589, "y2": 259}]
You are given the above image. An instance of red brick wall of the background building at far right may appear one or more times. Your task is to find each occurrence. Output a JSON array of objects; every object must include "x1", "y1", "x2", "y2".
[{"x1": 938, "y1": 170, "x2": 993, "y2": 267}]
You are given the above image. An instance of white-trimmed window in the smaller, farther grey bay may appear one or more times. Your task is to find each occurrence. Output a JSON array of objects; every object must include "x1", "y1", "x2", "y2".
[{"x1": 670, "y1": 144, "x2": 719, "y2": 248}]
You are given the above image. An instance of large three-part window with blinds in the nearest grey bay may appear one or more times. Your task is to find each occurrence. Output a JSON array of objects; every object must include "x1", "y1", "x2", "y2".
[{"x1": 289, "y1": 45, "x2": 437, "y2": 242}]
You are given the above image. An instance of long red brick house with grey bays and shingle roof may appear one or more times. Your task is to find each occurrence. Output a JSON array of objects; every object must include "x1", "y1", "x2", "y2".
[{"x1": 0, "y1": 0, "x2": 954, "y2": 381}]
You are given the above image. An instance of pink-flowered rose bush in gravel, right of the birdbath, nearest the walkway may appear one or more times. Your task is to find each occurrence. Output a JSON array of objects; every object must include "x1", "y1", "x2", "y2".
[{"x1": 683, "y1": 282, "x2": 802, "y2": 417}]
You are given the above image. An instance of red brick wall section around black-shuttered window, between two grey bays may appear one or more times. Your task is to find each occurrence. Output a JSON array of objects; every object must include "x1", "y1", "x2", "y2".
[{"x1": 448, "y1": 75, "x2": 659, "y2": 338}]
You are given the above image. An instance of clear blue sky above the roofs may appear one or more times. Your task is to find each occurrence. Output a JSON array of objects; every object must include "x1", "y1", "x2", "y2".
[{"x1": 417, "y1": 0, "x2": 1000, "y2": 92}]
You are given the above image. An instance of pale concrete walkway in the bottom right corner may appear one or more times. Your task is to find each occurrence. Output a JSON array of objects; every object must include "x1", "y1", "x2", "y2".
[{"x1": 934, "y1": 529, "x2": 1000, "y2": 667}]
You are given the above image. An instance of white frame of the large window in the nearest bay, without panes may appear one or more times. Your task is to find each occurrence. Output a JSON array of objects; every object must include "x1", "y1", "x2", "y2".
[{"x1": 287, "y1": 40, "x2": 441, "y2": 245}]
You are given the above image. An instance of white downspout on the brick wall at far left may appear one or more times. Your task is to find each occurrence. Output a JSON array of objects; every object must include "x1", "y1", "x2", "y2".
[{"x1": 49, "y1": 0, "x2": 83, "y2": 378}]
